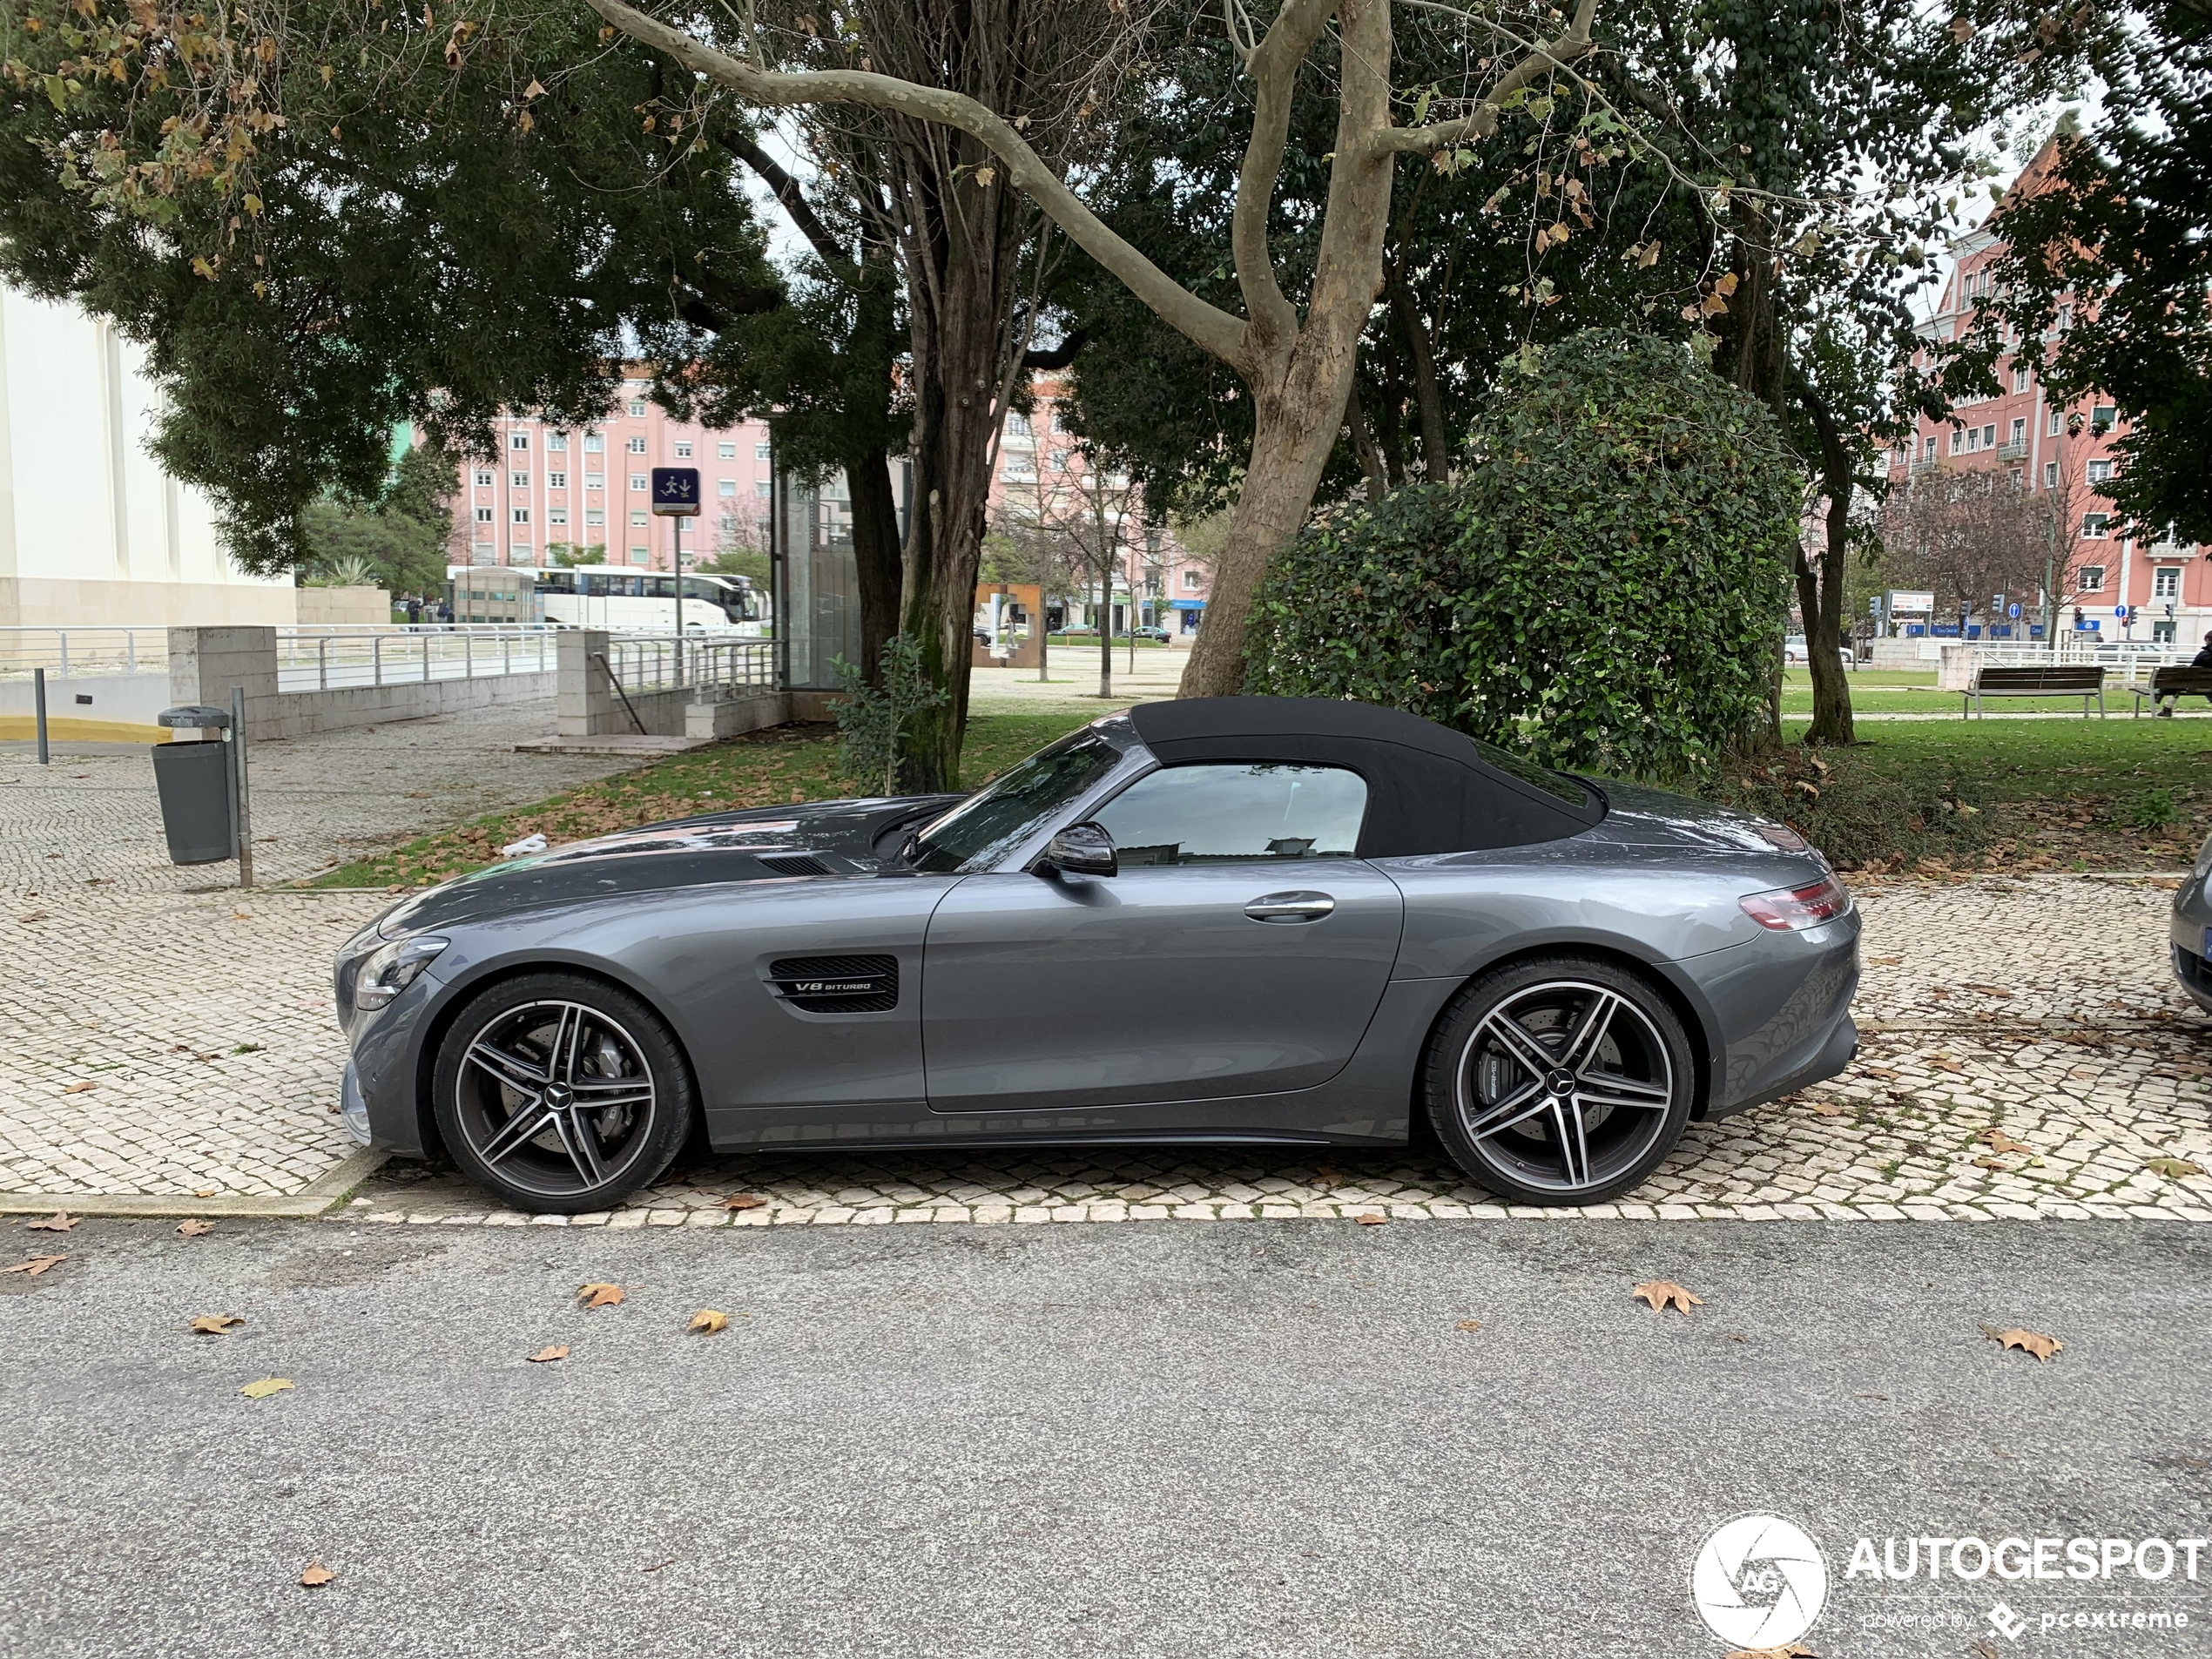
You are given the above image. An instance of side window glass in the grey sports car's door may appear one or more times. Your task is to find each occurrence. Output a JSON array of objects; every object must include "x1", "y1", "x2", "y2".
[{"x1": 1093, "y1": 761, "x2": 1367, "y2": 867}]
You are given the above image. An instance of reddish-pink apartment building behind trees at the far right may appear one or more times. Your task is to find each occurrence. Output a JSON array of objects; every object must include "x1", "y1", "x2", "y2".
[{"x1": 1889, "y1": 146, "x2": 2212, "y2": 651}]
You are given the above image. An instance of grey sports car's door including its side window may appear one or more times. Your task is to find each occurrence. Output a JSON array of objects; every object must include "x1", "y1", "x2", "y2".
[{"x1": 922, "y1": 761, "x2": 1402, "y2": 1113}]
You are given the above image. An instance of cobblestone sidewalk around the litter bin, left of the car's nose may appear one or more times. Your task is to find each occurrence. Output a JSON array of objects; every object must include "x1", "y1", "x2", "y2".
[{"x1": 0, "y1": 699, "x2": 622, "y2": 1197}]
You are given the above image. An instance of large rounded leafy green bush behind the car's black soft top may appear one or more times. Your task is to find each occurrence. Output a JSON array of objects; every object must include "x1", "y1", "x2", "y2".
[{"x1": 1250, "y1": 329, "x2": 1798, "y2": 777}]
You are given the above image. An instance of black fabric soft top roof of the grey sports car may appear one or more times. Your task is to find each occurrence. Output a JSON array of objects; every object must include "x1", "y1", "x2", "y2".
[{"x1": 1128, "y1": 697, "x2": 1606, "y2": 859}]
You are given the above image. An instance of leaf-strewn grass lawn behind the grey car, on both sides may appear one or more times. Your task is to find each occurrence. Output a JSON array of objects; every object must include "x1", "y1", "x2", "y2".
[{"x1": 314, "y1": 704, "x2": 2212, "y2": 887}]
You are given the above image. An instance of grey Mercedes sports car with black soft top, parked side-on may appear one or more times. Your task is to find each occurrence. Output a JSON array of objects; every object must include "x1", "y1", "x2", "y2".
[{"x1": 336, "y1": 697, "x2": 1858, "y2": 1212}]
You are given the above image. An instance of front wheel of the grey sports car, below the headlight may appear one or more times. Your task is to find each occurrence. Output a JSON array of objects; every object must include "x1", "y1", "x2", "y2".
[{"x1": 431, "y1": 974, "x2": 699, "y2": 1214}]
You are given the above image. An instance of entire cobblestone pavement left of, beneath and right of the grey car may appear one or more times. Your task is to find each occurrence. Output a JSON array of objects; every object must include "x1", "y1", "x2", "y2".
[{"x1": 0, "y1": 690, "x2": 2212, "y2": 1225}]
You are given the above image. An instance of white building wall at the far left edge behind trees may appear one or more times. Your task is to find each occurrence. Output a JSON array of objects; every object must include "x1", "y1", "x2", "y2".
[{"x1": 0, "y1": 287, "x2": 296, "y2": 626}]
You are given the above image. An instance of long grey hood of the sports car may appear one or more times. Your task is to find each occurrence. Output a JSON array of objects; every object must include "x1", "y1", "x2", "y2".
[{"x1": 376, "y1": 794, "x2": 964, "y2": 938}]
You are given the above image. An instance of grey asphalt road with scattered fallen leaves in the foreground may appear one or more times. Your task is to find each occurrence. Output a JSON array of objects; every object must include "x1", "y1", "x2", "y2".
[{"x1": 0, "y1": 1221, "x2": 2212, "y2": 1659}]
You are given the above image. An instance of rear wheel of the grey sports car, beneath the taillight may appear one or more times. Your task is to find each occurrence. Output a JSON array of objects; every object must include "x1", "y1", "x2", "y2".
[{"x1": 1420, "y1": 955, "x2": 1696, "y2": 1205}]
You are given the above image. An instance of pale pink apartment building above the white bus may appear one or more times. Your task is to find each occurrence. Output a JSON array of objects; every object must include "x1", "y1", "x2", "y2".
[{"x1": 454, "y1": 376, "x2": 770, "y2": 570}]
